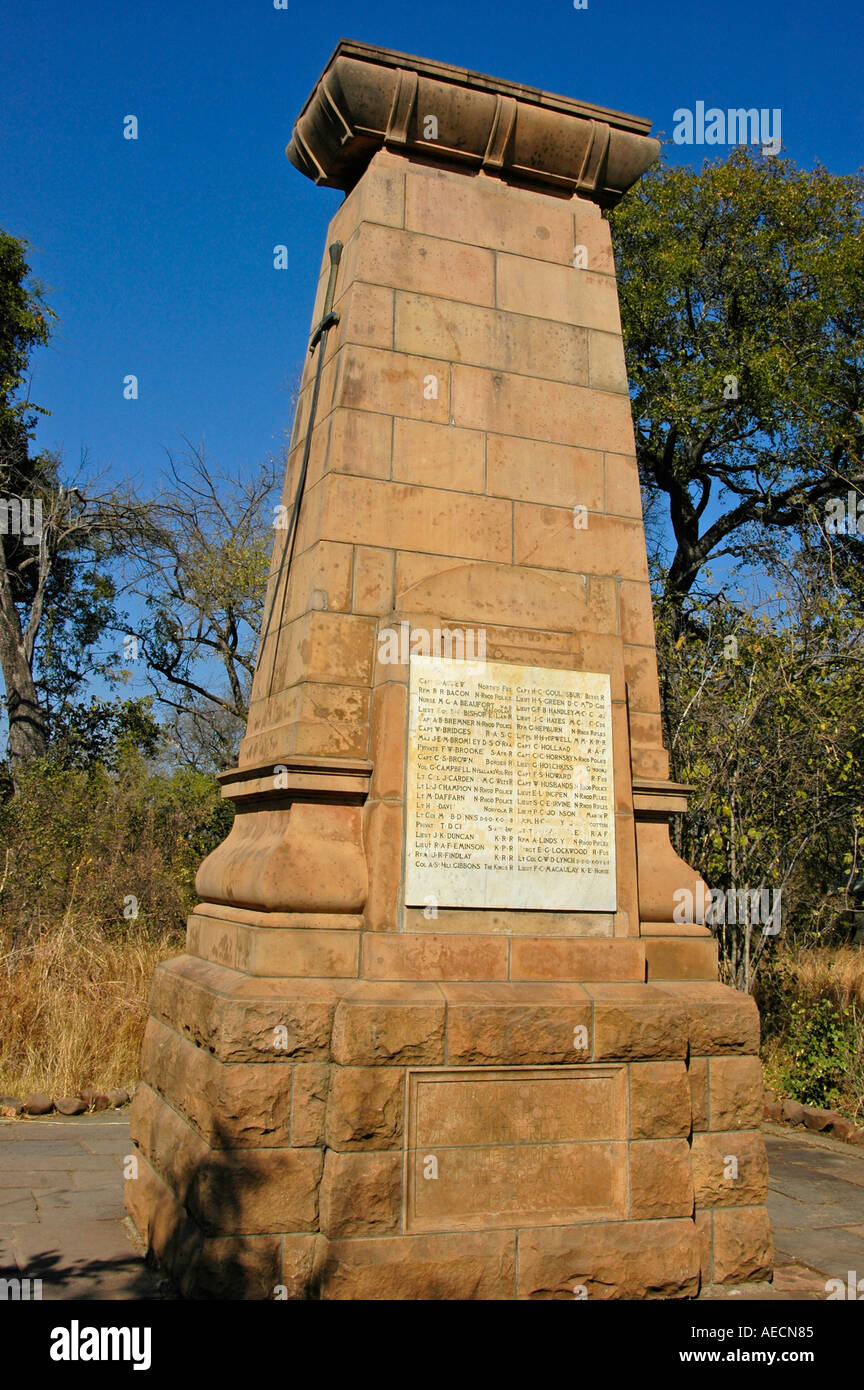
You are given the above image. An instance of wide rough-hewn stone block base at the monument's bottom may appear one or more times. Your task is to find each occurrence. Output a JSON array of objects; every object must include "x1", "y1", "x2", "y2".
[{"x1": 126, "y1": 939, "x2": 771, "y2": 1300}]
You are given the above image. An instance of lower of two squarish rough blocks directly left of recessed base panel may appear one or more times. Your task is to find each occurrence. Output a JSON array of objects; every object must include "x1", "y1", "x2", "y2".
[{"x1": 321, "y1": 1151, "x2": 403, "y2": 1238}]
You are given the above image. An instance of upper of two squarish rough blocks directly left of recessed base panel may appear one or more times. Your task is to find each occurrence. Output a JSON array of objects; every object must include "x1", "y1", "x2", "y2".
[{"x1": 326, "y1": 1066, "x2": 406, "y2": 1150}]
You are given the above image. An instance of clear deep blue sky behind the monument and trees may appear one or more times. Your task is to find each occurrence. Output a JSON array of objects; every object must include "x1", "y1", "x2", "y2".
[{"x1": 0, "y1": 0, "x2": 864, "y2": 484}]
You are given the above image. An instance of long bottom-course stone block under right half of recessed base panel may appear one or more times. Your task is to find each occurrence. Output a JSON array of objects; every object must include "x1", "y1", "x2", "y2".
[{"x1": 520, "y1": 1219, "x2": 700, "y2": 1301}]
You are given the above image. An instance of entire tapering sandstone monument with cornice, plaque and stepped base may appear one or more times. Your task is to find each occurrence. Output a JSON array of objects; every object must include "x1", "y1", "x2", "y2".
[{"x1": 126, "y1": 42, "x2": 771, "y2": 1300}]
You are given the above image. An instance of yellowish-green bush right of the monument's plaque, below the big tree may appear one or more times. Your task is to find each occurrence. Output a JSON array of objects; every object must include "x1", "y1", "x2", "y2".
[{"x1": 657, "y1": 549, "x2": 864, "y2": 990}]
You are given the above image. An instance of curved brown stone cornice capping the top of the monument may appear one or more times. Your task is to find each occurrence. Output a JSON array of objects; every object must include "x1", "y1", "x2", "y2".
[{"x1": 286, "y1": 39, "x2": 660, "y2": 207}]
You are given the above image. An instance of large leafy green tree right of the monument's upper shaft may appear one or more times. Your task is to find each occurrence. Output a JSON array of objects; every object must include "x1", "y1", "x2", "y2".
[{"x1": 610, "y1": 147, "x2": 864, "y2": 632}]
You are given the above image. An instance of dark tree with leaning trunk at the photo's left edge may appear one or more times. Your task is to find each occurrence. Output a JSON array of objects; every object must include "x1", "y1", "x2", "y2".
[{"x1": 0, "y1": 222, "x2": 156, "y2": 783}]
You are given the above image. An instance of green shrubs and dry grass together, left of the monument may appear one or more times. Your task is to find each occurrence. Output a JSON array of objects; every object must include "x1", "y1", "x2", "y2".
[{"x1": 0, "y1": 756, "x2": 231, "y2": 1097}]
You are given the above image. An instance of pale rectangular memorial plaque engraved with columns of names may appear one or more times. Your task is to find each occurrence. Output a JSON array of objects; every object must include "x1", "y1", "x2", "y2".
[{"x1": 406, "y1": 656, "x2": 617, "y2": 912}]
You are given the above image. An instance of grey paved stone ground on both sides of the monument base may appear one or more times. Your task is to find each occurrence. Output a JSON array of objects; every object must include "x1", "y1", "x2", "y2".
[{"x1": 0, "y1": 1111, "x2": 864, "y2": 1301}]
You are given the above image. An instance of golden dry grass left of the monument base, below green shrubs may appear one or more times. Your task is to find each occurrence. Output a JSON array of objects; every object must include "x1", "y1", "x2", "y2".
[{"x1": 0, "y1": 919, "x2": 183, "y2": 1099}]
